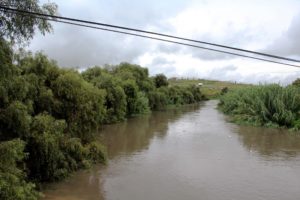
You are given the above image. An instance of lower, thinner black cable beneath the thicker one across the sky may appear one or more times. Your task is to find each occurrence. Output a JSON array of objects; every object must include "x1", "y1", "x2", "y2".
[{"x1": 0, "y1": 6, "x2": 300, "y2": 67}]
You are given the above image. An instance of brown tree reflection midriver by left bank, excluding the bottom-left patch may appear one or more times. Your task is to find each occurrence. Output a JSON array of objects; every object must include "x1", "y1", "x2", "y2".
[{"x1": 100, "y1": 105, "x2": 199, "y2": 159}]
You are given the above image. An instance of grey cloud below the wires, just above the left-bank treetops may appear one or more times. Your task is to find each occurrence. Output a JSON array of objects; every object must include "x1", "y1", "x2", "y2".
[{"x1": 32, "y1": 25, "x2": 148, "y2": 68}]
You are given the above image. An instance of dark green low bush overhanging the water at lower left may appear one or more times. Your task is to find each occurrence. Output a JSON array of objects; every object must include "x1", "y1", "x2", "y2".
[{"x1": 27, "y1": 114, "x2": 106, "y2": 182}]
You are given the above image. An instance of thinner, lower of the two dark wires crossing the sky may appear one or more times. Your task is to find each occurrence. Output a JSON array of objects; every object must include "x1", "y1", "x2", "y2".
[{"x1": 0, "y1": 5, "x2": 300, "y2": 67}]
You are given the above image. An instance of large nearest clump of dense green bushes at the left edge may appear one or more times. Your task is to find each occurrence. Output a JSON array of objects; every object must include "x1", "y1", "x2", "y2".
[{"x1": 0, "y1": 40, "x2": 106, "y2": 199}]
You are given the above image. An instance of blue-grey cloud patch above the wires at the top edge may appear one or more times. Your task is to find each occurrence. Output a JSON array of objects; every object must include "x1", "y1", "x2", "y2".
[{"x1": 94, "y1": 0, "x2": 190, "y2": 28}]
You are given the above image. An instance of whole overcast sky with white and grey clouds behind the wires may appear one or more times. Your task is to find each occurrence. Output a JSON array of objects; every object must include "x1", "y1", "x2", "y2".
[{"x1": 28, "y1": 0, "x2": 300, "y2": 84}]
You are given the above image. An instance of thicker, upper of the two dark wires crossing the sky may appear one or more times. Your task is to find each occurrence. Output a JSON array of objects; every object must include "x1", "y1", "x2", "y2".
[{"x1": 0, "y1": 5, "x2": 300, "y2": 63}]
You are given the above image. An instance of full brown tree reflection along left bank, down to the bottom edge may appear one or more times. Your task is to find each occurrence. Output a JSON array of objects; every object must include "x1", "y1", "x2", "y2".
[{"x1": 44, "y1": 104, "x2": 200, "y2": 200}]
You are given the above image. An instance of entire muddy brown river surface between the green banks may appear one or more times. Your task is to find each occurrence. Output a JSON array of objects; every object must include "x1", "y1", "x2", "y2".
[{"x1": 44, "y1": 101, "x2": 300, "y2": 200}]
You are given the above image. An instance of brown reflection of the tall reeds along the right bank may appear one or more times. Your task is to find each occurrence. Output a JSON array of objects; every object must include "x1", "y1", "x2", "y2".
[{"x1": 238, "y1": 126, "x2": 300, "y2": 159}]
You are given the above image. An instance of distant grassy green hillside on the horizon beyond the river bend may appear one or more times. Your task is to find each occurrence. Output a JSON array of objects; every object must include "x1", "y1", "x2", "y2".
[{"x1": 169, "y1": 78, "x2": 249, "y2": 99}]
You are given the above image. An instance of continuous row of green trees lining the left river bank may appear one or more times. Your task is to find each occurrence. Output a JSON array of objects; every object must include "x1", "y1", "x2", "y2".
[{"x1": 0, "y1": 40, "x2": 204, "y2": 200}]
